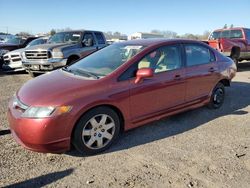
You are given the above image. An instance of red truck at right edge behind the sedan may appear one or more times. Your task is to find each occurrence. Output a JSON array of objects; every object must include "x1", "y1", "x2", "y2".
[{"x1": 207, "y1": 27, "x2": 250, "y2": 66}]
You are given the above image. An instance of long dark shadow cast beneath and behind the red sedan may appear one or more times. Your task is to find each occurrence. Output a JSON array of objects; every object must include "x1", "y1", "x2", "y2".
[{"x1": 66, "y1": 82, "x2": 250, "y2": 157}]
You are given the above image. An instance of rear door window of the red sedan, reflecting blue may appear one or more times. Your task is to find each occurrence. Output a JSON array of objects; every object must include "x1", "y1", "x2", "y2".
[{"x1": 185, "y1": 44, "x2": 215, "y2": 66}]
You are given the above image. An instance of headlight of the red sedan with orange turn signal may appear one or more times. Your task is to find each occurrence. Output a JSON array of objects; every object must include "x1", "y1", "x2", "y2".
[{"x1": 22, "y1": 106, "x2": 72, "y2": 118}]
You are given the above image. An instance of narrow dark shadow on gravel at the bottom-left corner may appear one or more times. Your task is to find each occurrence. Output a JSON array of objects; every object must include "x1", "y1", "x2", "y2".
[{"x1": 5, "y1": 168, "x2": 74, "y2": 188}]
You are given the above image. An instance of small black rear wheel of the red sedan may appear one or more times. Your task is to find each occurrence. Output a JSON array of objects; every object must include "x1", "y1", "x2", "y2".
[{"x1": 208, "y1": 82, "x2": 225, "y2": 109}]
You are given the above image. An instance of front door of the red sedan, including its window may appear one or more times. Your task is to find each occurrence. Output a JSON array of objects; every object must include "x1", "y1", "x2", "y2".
[{"x1": 130, "y1": 45, "x2": 186, "y2": 122}]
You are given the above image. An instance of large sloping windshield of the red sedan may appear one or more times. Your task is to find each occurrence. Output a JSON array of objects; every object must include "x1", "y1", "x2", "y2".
[{"x1": 64, "y1": 43, "x2": 145, "y2": 77}]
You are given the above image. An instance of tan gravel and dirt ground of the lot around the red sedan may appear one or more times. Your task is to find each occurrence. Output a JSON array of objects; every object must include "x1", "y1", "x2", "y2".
[{"x1": 0, "y1": 62, "x2": 250, "y2": 188}]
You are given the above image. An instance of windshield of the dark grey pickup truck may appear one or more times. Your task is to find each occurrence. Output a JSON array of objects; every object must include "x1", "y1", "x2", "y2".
[{"x1": 49, "y1": 32, "x2": 81, "y2": 43}]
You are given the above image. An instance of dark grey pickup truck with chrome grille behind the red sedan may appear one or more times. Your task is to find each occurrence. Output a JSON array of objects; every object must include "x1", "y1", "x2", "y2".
[{"x1": 22, "y1": 30, "x2": 107, "y2": 77}]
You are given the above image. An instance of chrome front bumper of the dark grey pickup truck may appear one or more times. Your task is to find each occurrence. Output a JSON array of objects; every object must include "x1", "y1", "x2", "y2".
[{"x1": 23, "y1": 58, "x2": 67, "y2": 73}]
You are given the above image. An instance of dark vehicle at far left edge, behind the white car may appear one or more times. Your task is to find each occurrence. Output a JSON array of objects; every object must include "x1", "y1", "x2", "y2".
[{"x1": 0, "y1": 37, "x2": 37, "y2": 69}]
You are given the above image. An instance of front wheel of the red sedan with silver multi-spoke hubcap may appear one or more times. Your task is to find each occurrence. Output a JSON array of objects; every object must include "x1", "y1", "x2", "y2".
[{"x1": 72, "y1": 107, "x2": 121, "y2": 155}]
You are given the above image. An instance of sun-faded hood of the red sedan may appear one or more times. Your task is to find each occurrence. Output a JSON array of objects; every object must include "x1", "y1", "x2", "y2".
[{"x1": 17, "y1": 70, "x2": 103, "y2": 106}]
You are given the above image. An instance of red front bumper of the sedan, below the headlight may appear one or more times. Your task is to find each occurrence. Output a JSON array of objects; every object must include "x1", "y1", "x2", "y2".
[{"x1": 8, "y1": 101, "x2": 71, "y2": 153}]
